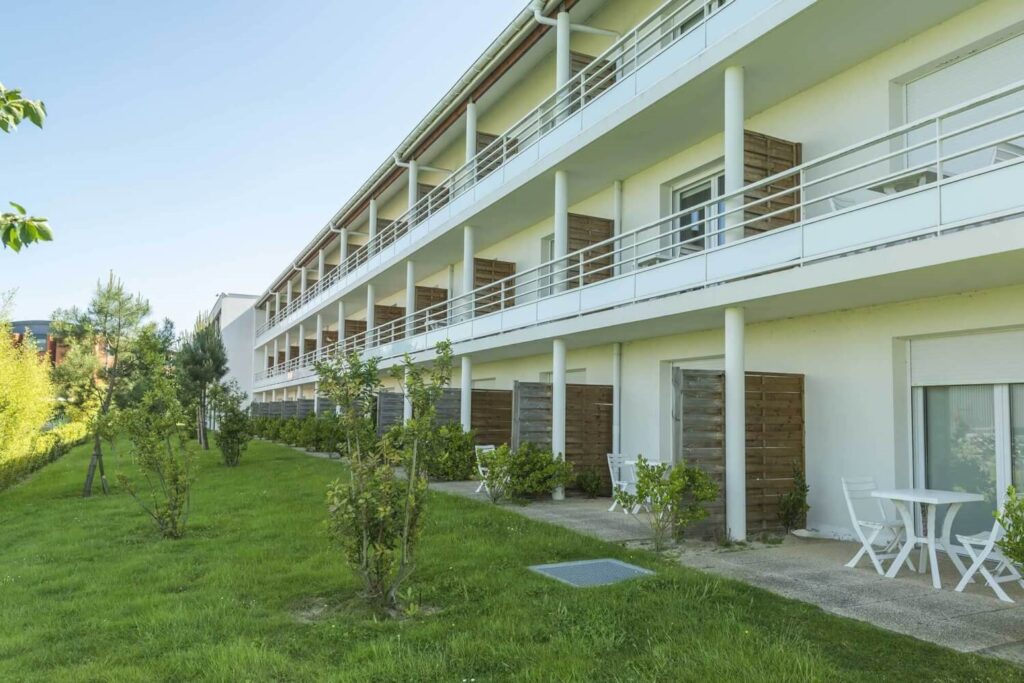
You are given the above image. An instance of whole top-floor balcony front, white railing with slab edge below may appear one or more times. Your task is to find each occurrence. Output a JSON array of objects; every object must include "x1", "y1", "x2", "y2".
[{"x1": 256, "y1": 0, "x2": 781, "y2": 344}]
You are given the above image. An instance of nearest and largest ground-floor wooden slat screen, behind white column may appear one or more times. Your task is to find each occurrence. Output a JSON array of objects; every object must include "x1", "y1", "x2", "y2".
[{"x1": 673, "y1": 368, "x2": 805, "y2": 539}]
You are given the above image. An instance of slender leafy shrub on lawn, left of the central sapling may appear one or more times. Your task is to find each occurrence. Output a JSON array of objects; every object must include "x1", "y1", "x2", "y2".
[{"x1": 118, "y1": 379, "x2": 194, "y2": 539}]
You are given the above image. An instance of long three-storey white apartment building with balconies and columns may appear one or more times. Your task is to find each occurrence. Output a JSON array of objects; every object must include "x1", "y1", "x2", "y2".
[{"x1": 245, "y1": 0, "x2": 1024, "y2": 538}]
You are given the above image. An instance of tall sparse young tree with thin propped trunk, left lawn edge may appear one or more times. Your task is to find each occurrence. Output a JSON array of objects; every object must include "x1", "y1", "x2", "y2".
[{"x1": 53, "y1": 272, "x2": 150, "y2": 498}]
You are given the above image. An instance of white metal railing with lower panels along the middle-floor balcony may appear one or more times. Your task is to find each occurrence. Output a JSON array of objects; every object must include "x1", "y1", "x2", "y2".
[{"x1": 257, "y1": 81, "x2": 1024, "y2": 380}]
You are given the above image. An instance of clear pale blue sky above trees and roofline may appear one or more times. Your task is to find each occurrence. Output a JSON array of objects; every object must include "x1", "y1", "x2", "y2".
[{"x1": 0, "y1": 0, "x2": 525, "y2": 326}]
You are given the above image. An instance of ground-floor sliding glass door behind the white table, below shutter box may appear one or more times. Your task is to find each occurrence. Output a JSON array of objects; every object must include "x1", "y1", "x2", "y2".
[{"x1": 913, "y1": 384, "x2": 1024, "y2": 533}]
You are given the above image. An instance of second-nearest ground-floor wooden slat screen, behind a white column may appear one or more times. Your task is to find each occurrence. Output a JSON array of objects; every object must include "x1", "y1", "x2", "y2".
[{"x1": 512, "y1": 382, "x2": 611, "y2": 496}]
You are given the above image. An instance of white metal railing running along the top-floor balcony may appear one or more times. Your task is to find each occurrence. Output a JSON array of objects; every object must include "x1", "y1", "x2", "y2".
[{"x1": 256, "y1": 0, "x2": 734, "y2": 336}]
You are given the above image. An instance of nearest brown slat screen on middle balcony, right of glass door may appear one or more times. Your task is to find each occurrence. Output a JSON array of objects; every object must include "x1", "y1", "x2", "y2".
[{"x1": 743, "y1": 130, "x2": 803, "y2": 237}]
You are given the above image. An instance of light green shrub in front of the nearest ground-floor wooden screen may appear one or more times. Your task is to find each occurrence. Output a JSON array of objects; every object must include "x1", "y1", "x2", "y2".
[{"x1": 614, "y1": 456, "x2": 718, "y2": 551}]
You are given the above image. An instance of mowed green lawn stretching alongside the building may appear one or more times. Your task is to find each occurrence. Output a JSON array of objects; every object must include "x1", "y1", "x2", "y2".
[{"x1": 0, "y1": 442, "x2": 1022, "y2": 682}]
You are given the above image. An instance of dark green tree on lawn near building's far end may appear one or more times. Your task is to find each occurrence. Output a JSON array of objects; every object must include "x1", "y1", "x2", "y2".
[{"x1": 175, "y1": 315, "x2": 227, "y2": 451}]
